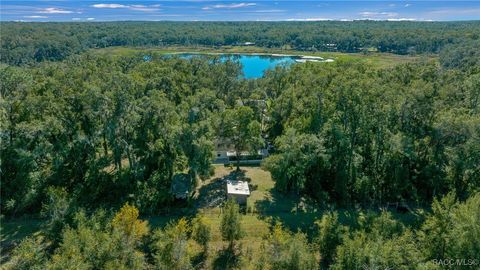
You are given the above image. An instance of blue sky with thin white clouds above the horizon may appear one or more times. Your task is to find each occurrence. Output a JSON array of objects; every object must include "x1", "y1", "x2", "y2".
[{"x1": 0, "y1": 0, "x2": 480, "y2": 22}]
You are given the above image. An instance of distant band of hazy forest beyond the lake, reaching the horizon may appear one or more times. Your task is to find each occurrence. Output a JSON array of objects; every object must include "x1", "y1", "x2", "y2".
[{"x1": 0, "y1": 21, "x2": 480, "y2": 65}]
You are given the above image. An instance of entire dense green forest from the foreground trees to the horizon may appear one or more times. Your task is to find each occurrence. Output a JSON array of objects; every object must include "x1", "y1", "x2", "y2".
[{"x1": 0, "y1": 22, "x2": 480, "y2": 269}]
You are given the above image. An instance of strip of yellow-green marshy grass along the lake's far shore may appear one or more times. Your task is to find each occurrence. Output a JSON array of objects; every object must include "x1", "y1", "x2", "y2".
[{"x1": 90, "y1": 46, "x2": 437, "y2": 68}]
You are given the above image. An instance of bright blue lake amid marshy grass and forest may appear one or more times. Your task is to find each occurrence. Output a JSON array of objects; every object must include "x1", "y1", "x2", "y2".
[{"x1": 179, "y1": 53, "x2": 298, "y2": 79}]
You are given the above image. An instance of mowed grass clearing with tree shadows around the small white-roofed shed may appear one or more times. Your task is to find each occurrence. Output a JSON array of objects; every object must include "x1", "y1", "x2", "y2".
[{"x1": 148, "y1": 165, "x2": 321, "y2": 251}]
